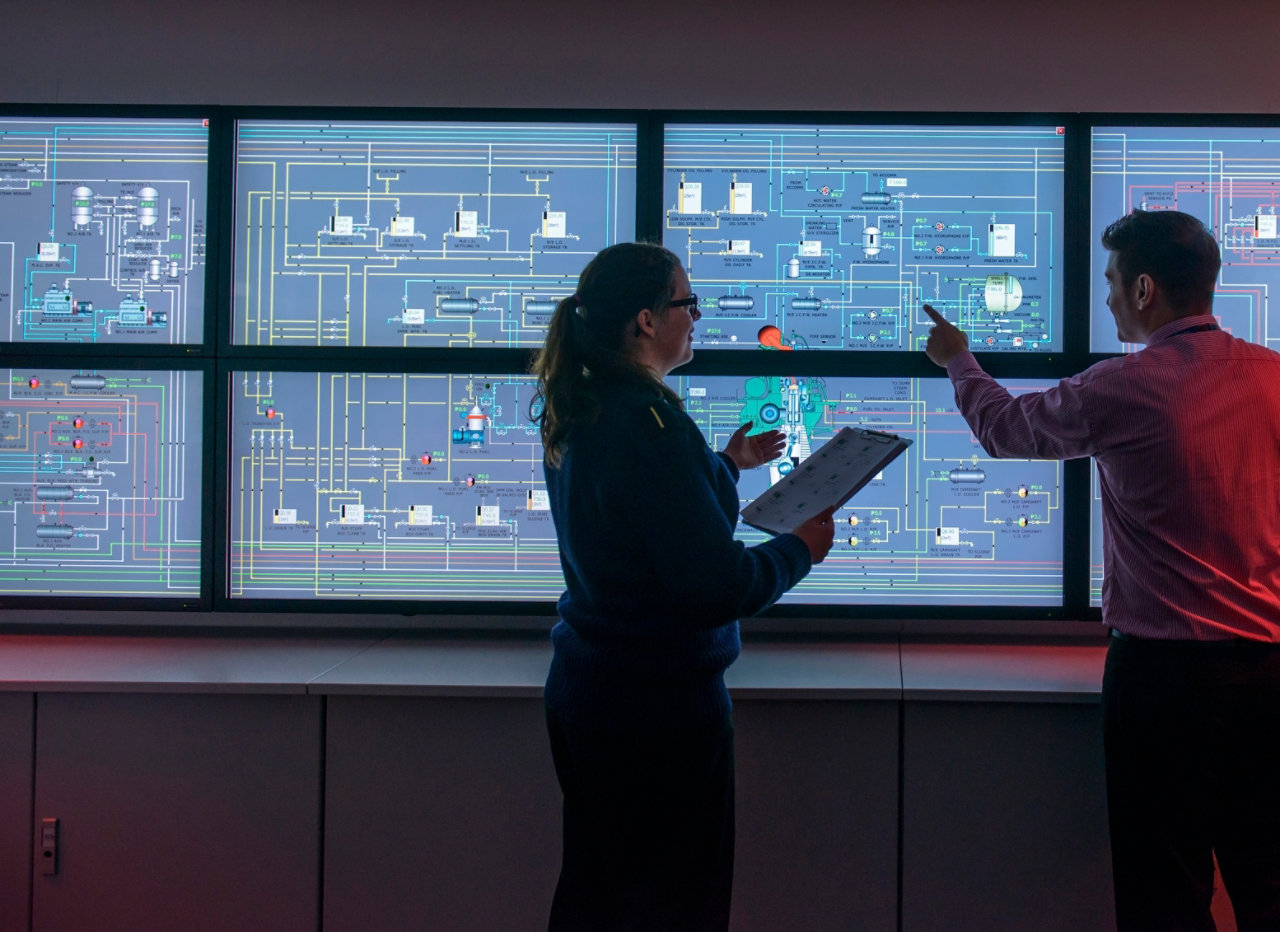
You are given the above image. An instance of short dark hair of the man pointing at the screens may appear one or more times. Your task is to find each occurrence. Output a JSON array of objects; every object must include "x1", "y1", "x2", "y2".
[{"x1": 1102, "y1": 210, "x2": 1222, "y2": 311}]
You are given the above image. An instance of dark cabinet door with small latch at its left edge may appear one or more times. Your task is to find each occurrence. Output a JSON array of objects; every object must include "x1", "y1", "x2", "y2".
[{"x1": 32, "y1": 693, "x2": 321, "y2": 932}]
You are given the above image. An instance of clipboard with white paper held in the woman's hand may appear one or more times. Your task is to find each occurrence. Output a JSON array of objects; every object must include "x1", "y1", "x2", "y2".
[{"x1": 741, "y1": 428, "x2": 911, "y2": 534}]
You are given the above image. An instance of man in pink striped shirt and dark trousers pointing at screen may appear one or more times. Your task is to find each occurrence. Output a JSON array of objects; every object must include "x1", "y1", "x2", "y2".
[{"x1": 925, "y1": 210, "x2": 1280, "y2": 932}]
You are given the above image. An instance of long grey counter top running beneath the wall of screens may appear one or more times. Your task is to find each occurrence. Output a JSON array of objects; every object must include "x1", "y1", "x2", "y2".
[{"x1": 0, "y1": 635, "x2": 1106, "y2": 702}]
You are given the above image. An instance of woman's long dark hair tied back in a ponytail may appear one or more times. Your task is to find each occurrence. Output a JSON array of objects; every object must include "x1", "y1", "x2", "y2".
[{"x1": 530, "y1": 243, "x2": 681, "y2": 466}]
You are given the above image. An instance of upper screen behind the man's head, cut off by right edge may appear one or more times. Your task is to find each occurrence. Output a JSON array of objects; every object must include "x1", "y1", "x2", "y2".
[{"x1": 1089, "y1": 125, "x2": 1280, "y2": 352}]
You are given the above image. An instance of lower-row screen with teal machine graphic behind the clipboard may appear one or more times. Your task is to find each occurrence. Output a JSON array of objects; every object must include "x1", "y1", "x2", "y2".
[{"x1": 677, "y1": 375, "x2": 1062, "y2": 606}]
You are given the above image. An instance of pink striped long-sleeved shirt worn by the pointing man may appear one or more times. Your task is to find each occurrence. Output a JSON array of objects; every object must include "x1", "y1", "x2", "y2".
[{"x1": 947, "y1": 315, "x2": 1280, "y2": 641}]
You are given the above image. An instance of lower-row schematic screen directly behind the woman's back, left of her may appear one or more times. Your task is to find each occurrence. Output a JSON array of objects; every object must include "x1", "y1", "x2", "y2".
[{"x1": 229, "y1": 371, "x2": 564, "y2": 603}]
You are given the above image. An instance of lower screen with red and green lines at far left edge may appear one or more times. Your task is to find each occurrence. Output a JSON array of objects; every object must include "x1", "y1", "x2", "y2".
[{"x1": 0, "y1": 366, "x2": 199, "y2": 600}]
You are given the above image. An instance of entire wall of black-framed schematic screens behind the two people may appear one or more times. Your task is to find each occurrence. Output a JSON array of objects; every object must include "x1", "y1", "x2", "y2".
[{"x1": 0, "y1": 106, "x2": 1280, "y2": 630}]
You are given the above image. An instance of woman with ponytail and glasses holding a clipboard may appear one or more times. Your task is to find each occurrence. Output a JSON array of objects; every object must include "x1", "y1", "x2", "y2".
[{"x1": 534, "y1": 243, "x2": 833, "y2": 932}]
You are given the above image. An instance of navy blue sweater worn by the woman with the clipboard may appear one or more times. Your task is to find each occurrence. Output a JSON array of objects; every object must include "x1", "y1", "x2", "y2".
[{"x1": 545, "y1": 383, "x2": 810, "y2": 730}]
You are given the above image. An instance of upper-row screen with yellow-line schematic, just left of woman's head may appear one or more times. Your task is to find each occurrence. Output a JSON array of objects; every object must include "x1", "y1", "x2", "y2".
[{"x1": 232, "y1": 120, "x2": 637, "y2": 348}]
